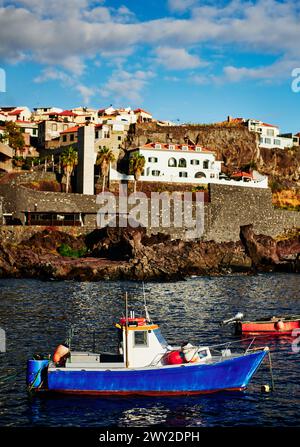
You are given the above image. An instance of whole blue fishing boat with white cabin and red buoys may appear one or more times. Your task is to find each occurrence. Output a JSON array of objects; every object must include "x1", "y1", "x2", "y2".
[{"x1": 27, "y1": 298, "x2": 269, "y2": 396}]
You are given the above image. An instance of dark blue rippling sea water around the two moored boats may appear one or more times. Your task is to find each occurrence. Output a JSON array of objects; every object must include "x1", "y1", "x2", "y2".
[{"x1": 0, "y1": 274, "x2": 300, "y2": 428}]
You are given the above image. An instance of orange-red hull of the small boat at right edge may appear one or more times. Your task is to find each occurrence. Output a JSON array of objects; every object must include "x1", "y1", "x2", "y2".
[{"x1": 236, "y1": 320, "x2": 300, "y2": 335}]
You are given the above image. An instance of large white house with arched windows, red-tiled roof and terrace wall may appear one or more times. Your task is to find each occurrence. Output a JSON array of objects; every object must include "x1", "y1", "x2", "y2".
[{"x1": 110, "y1": 143, "x2": 268, "y2": 188}]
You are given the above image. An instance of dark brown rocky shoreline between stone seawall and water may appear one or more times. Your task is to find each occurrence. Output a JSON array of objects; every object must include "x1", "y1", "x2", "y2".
[{"x1": 0, "y1": 226, "x2": 300, "y2": 281}]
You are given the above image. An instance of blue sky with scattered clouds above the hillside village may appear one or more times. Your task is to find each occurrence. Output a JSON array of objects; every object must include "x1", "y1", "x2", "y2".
[{"x1": 0, "y1": 0, "x2": 300, "y2": 132}]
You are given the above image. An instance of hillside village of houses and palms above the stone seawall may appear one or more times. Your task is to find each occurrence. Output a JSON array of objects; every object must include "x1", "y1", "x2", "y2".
[{"x1": 0, "y1": 105, "x2": 300, "y2": 228}]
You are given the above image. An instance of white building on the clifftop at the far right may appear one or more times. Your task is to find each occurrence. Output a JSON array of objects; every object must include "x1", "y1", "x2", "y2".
[{"x1": 247, "y1": 119, "x2": 297, "y2": 149}]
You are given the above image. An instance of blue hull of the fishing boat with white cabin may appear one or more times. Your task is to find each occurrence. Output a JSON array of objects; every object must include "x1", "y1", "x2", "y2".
[{"x1": 42, "y1": 350, "x2": 267, "y2": 396}]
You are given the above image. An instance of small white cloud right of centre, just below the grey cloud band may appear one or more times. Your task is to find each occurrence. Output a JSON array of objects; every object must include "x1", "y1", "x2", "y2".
[{"x1": 155, "y1": 47, "x2": 207, "y2": 70}]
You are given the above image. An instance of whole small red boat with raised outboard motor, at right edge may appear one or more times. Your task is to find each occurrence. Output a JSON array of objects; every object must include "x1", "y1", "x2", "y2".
[{"x1": 222, "y1": 313, "x2": 300, "y2": 335}]
